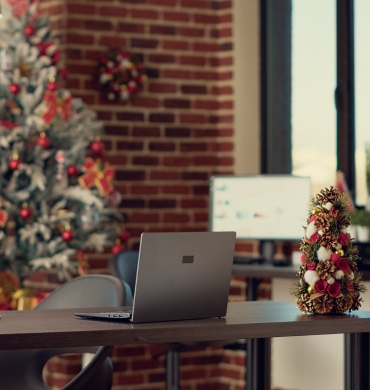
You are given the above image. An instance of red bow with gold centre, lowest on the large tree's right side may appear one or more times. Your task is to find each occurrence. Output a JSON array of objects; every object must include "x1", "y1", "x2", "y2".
[{"x1": 78, "y1": 157, "x2": 114, "y2": 195}]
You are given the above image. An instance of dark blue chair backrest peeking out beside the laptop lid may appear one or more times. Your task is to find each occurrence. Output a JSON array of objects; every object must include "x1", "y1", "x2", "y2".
[{"x1": 108, "y1": 251, "x2": 139, "y2": 294}]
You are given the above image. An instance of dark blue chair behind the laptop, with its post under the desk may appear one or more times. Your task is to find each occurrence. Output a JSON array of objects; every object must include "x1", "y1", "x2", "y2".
[{"x1": 108, "y1": 251, "x2": 235, "y2": 390}]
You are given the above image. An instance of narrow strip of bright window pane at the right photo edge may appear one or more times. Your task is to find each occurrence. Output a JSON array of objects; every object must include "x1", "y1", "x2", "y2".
[{"x1": 355, "y1": 0, "x2": 370, "y2": 205}]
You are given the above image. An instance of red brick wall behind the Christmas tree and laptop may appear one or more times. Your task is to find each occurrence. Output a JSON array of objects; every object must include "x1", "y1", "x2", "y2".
[{"x1": 35, "y1": 0, "x2": 253, "y2": 390}]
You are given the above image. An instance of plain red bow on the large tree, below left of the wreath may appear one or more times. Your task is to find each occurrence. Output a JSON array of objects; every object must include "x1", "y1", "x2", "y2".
[{"x1": 41, "y1": 90, "x2": 72, "y2": 125}]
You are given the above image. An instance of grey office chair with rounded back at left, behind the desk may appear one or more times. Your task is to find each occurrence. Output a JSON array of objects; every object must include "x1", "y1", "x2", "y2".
[{"x1": 0, "y1": 275, "x2": 127, "y2": 390}]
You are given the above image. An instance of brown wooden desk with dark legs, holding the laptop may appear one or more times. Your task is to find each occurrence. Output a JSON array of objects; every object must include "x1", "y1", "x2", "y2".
[{"x1": 0, "y1": 301, "x2": 370, "y2": 390}]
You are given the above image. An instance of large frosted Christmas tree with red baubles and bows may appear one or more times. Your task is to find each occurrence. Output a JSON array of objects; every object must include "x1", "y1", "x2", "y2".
[{"x1": 0, "y1": 0, "x2": 127, "y2": 278}]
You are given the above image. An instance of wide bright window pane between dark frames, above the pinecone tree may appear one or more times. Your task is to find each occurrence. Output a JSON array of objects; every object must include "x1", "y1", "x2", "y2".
[{"x1": 292, "y1": 0, "x2": 337, "y2": 194}]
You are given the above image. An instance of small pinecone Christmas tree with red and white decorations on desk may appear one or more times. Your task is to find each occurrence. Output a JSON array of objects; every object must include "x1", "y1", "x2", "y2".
[{"x1": 293, "y1": 187, "x2": 365, "y2": 314}]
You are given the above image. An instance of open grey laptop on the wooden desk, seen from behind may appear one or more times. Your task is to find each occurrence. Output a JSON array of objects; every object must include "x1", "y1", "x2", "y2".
[{"x1": 75, "y1": 232, "x2": 236, "y2": 322}]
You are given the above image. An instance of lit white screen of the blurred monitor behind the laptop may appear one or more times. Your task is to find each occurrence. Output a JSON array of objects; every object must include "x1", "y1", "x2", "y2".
[{"x1": 209, "y1": 175, "x2": 311, "y2": 241}]
